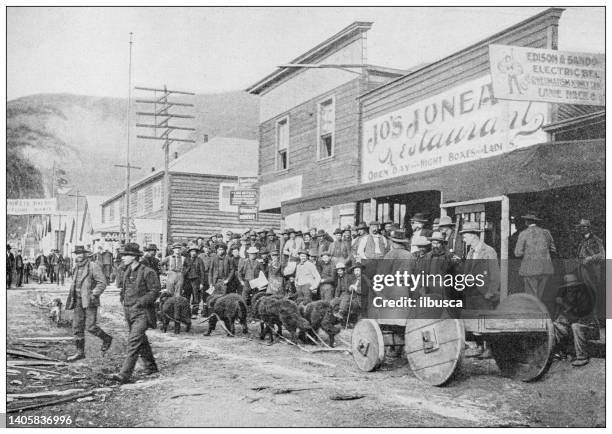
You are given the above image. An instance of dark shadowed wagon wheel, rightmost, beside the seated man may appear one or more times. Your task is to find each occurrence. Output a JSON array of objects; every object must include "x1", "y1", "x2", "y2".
[{"x1": 487, "y1": 294, "x2": 555, "y2": 381}]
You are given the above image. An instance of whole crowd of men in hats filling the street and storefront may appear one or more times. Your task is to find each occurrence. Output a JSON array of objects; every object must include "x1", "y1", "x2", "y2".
[{"x1": 7, "y1": 212, "x2": 605, "y2": 381}]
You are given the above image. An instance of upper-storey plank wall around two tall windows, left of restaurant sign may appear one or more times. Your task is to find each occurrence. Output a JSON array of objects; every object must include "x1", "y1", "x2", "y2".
[{"x1": 259, "y1": 79, "x2": 361, "y2": 195}]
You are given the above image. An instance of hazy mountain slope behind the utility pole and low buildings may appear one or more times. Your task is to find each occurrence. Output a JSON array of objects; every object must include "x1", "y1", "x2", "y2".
[{"x1": 7, "y1": 91, "x2": 259, "y2": 208}]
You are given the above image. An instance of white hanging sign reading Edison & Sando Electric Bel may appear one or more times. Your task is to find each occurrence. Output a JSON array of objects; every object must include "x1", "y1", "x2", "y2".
[{"x1": 489, "y1": 45, "x2": 606, "y2": 106}]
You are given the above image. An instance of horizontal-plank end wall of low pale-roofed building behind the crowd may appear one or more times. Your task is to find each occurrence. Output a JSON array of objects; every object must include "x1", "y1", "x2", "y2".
[{"x1": 168, "y1": 174, "x2": 281, "y2": 241}]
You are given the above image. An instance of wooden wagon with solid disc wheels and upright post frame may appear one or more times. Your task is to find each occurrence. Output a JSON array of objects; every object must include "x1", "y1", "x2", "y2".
[{"x1": 351, "y1": 196, "x2": 554, "y2": 386}]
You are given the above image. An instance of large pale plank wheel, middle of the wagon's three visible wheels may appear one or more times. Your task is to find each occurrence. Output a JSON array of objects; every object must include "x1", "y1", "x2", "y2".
[{"x1": 404, "y1": 318, "x2": 465, "y2": 386}]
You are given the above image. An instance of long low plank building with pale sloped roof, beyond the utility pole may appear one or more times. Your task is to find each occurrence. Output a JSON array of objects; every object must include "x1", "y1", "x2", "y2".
[{"x1": 100, "y1": 137, "x2": 280, "y2": 251}]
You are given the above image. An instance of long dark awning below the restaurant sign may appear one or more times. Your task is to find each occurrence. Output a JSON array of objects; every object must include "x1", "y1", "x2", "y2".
[{"x1": 281, "y1": 139, "x2": 606, "y2": 216}]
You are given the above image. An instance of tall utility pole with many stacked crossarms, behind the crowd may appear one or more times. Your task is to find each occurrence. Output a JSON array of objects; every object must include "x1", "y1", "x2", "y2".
[{"x1": 135, "y1": 85, "x2": 195, "y2": 256}]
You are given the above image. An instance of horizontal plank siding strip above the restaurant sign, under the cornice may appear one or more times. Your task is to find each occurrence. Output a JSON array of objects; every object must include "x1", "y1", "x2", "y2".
[{"x1": 361, "y1": 9, "x2": 561, "y2": 121}]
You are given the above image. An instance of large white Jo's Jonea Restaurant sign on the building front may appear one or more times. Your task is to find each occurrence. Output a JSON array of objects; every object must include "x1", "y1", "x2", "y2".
[{"x1": 361, "y1": 75, "x2": 548, "y2": 183}]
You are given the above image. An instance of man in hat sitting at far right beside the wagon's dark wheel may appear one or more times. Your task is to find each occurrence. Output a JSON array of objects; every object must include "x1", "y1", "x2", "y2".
[{"x1": 553, "y1": 274, "x2": 599, "y2": 367}]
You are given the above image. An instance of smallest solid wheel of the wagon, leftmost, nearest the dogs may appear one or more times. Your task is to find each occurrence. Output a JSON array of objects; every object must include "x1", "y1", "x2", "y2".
[{"x1": 351, "y1": 319, "x2": 385, "y2": 372}]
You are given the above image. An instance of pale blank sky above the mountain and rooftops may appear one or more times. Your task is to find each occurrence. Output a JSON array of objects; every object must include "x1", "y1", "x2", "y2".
[{"x1": 7, "y1": 7, "x2": 605, "y2": 100}]
